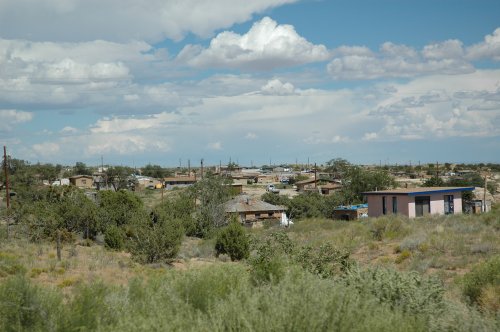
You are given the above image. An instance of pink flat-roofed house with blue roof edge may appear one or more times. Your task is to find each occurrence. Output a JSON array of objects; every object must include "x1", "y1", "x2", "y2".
[{"x1": 363, "y1": 187, "x2": 474, "y2": 218}]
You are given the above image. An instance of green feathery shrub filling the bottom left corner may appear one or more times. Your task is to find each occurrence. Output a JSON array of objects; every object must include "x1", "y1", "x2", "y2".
[{"x1": 0, "y1": 276, "x2": 62, "y2": 331}]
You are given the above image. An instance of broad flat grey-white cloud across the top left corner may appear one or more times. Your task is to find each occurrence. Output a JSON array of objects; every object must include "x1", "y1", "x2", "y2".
[{"x1": 0, "y1": 0, "x2": 296, "y2": 42}]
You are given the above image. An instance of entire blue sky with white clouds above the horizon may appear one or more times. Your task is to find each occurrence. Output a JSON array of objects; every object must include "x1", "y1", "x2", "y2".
[{"x1": 0, "y1": 0, "x2": 500, "y2": 167}]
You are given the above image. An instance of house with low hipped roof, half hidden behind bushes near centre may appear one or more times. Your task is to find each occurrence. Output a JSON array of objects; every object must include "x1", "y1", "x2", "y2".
[{"x1": 224, "y1": 195, "x2": 286, "y2": 222}]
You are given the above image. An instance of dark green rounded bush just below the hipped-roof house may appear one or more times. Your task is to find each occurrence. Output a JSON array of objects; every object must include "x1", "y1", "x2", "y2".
[{"x1": 215, "y1": 221, "x2": 250, "y2": 261}]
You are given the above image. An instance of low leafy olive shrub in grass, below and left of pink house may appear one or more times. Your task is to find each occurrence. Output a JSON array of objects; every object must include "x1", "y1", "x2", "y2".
[{"x1": 295, "y1": 243, "x2": 353, "y2": 278}]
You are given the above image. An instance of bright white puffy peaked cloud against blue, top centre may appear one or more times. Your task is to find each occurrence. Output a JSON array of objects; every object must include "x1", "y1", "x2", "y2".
[{"x1": 178, "y1": 17, "x2": 329, "y2": 70}]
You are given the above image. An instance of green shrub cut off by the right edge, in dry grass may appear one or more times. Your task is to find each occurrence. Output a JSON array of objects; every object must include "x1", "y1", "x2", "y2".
[{"x1": 462, "y1": 255, "x2": 500, "y2": 304}]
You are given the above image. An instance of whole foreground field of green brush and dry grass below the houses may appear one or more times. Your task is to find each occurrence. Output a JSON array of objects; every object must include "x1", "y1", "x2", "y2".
[{"x1": 0, "y1": 183, "x2": 500, "y2": 331}]
